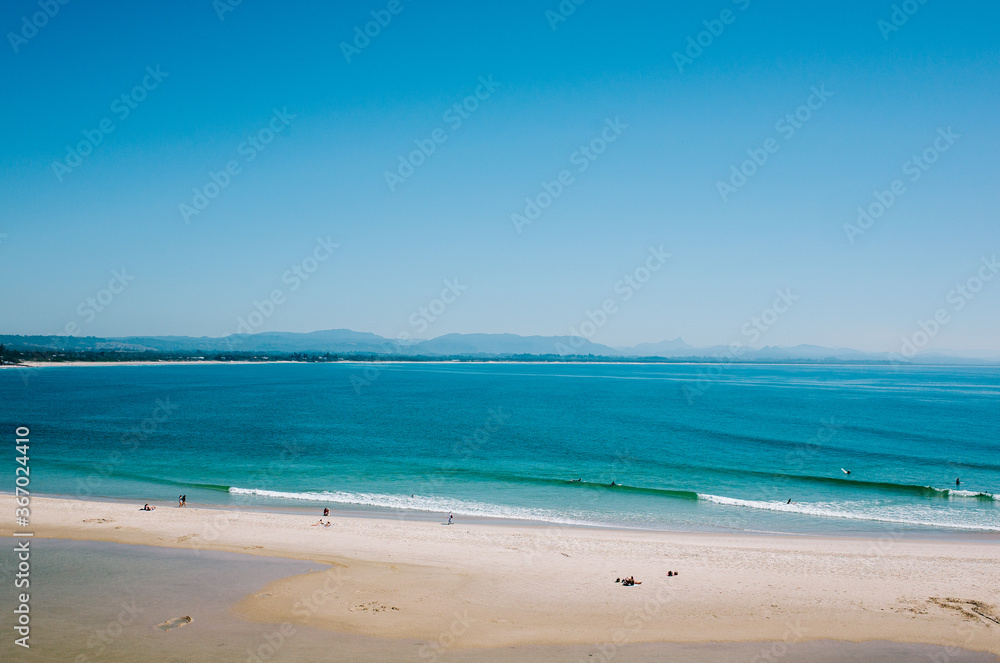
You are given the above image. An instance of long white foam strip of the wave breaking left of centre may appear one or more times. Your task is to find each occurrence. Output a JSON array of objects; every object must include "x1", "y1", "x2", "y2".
[{"x1": 229, "y1": 487, "x2": 598, "y2": 525}]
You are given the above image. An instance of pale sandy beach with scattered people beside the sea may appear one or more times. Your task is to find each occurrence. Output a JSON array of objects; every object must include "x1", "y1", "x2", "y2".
[{"x1": 0, "y1": 495, "x2": 1000, "y2": 654}]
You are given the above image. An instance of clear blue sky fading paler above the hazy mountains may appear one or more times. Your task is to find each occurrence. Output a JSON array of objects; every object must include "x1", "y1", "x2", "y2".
[{"x1": 0, "y1": 0, "x2": 1000, "y2": 352}]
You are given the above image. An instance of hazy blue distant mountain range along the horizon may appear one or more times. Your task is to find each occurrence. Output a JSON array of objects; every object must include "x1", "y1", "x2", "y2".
[{"x1": 0, "y1": 329, "x2": 1000, "y2": 365}]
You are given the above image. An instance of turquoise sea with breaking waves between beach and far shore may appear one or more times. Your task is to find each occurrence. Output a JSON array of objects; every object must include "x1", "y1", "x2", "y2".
[{"x1": 0, "y1": 363, "x2": 1000, "y2": 536}]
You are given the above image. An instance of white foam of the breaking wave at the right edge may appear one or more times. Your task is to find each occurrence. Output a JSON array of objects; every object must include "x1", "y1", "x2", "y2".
[{"x1": 698, "y1": 493, "x2": 1000, "y2": 532}]
